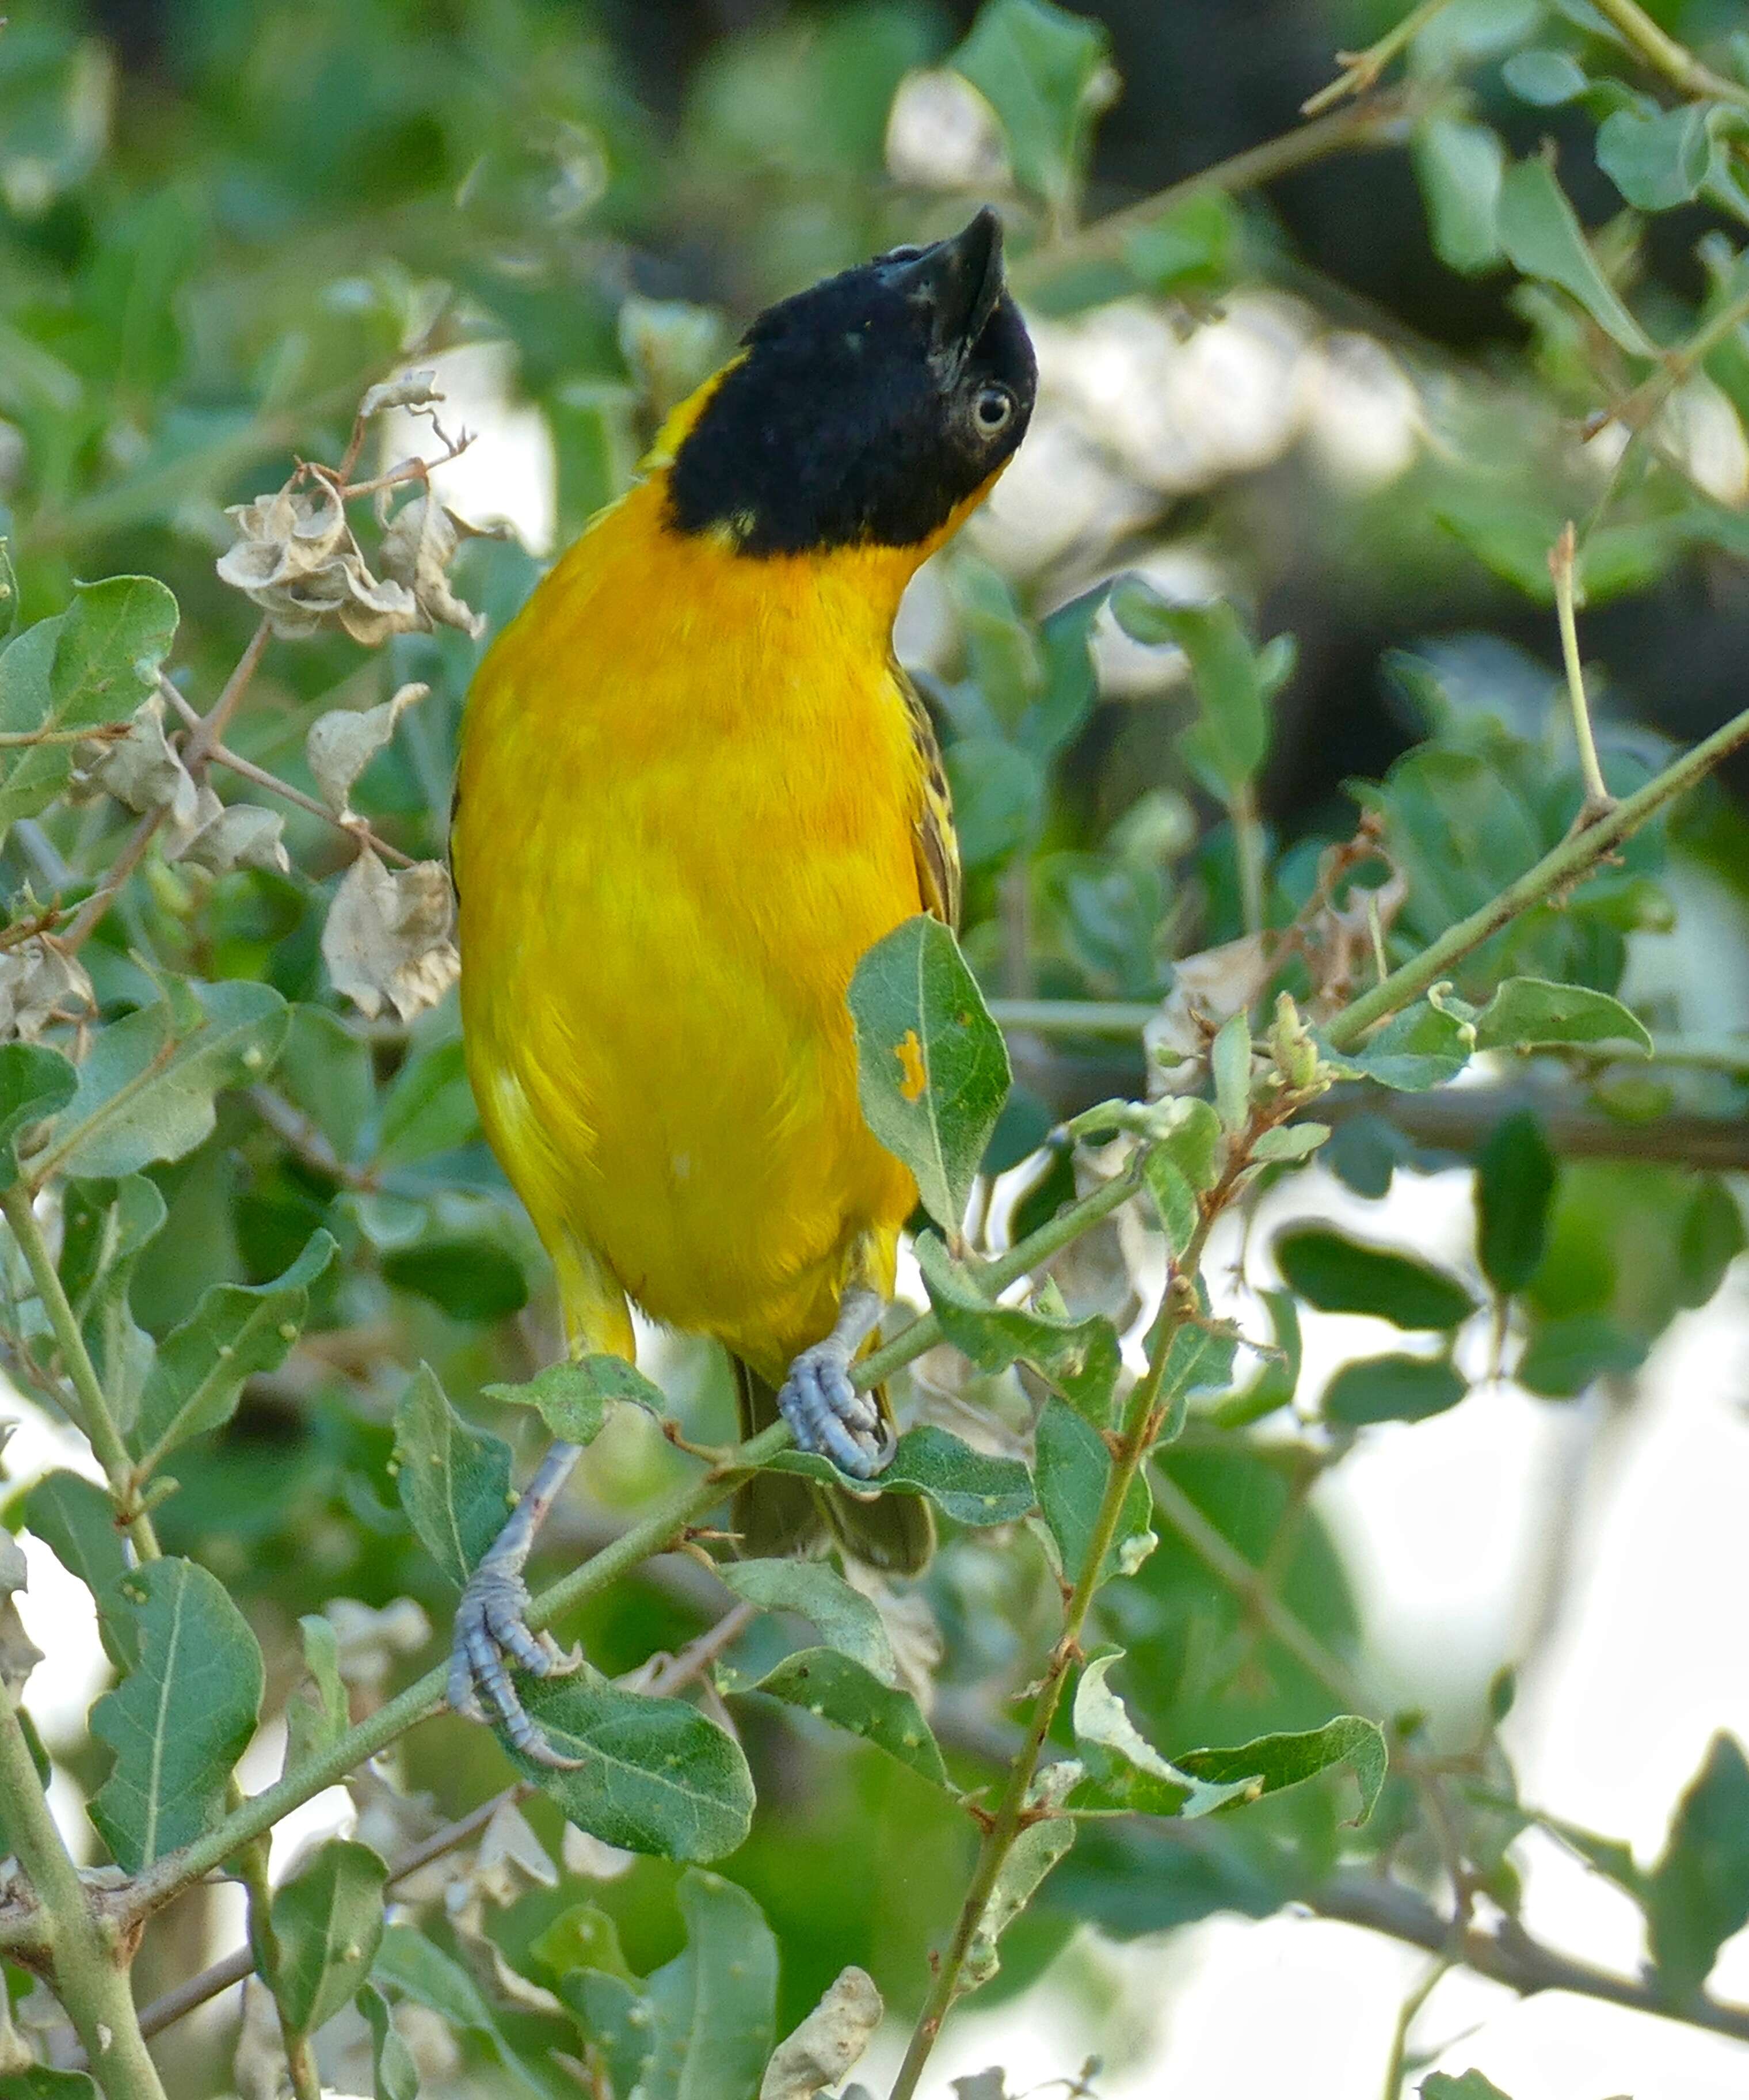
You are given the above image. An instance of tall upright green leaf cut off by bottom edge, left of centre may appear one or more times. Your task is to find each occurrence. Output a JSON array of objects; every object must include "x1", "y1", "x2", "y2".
[{"x1": 638, "y1": 1871, "x2": 777, "y2": 2100}]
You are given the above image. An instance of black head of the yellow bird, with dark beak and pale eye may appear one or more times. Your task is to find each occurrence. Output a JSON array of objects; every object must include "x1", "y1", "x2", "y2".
[{"x1": 668, "y1": 210, "x2": 1037, "y2": 554}]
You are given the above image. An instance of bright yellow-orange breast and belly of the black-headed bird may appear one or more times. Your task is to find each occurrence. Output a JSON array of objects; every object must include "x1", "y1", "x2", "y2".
[{"x1": 456, "y1": 483, "x2": 920, "y2": 1375}]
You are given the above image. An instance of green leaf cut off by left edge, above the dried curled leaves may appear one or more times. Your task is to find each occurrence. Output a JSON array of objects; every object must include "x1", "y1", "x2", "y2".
[{"x1": 0, "y1": 576, "x2": 176, "y2": 834}]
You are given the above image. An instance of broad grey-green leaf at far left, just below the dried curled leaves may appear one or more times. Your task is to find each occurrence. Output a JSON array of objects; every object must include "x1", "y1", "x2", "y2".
[{"x1": 51, "y1": 981, "x2": 292, "y2": 1178}]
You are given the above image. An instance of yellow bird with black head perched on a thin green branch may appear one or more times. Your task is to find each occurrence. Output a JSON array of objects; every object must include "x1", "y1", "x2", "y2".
[{"x1": 451, "y1": 210, "x2": 1035, "y2": 1762}]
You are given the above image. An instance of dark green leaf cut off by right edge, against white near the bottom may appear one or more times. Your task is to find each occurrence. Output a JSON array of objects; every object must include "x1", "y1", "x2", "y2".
[{"x1": 1646, "y1": 1734, "x2": 1749, "y2": 2006}]
